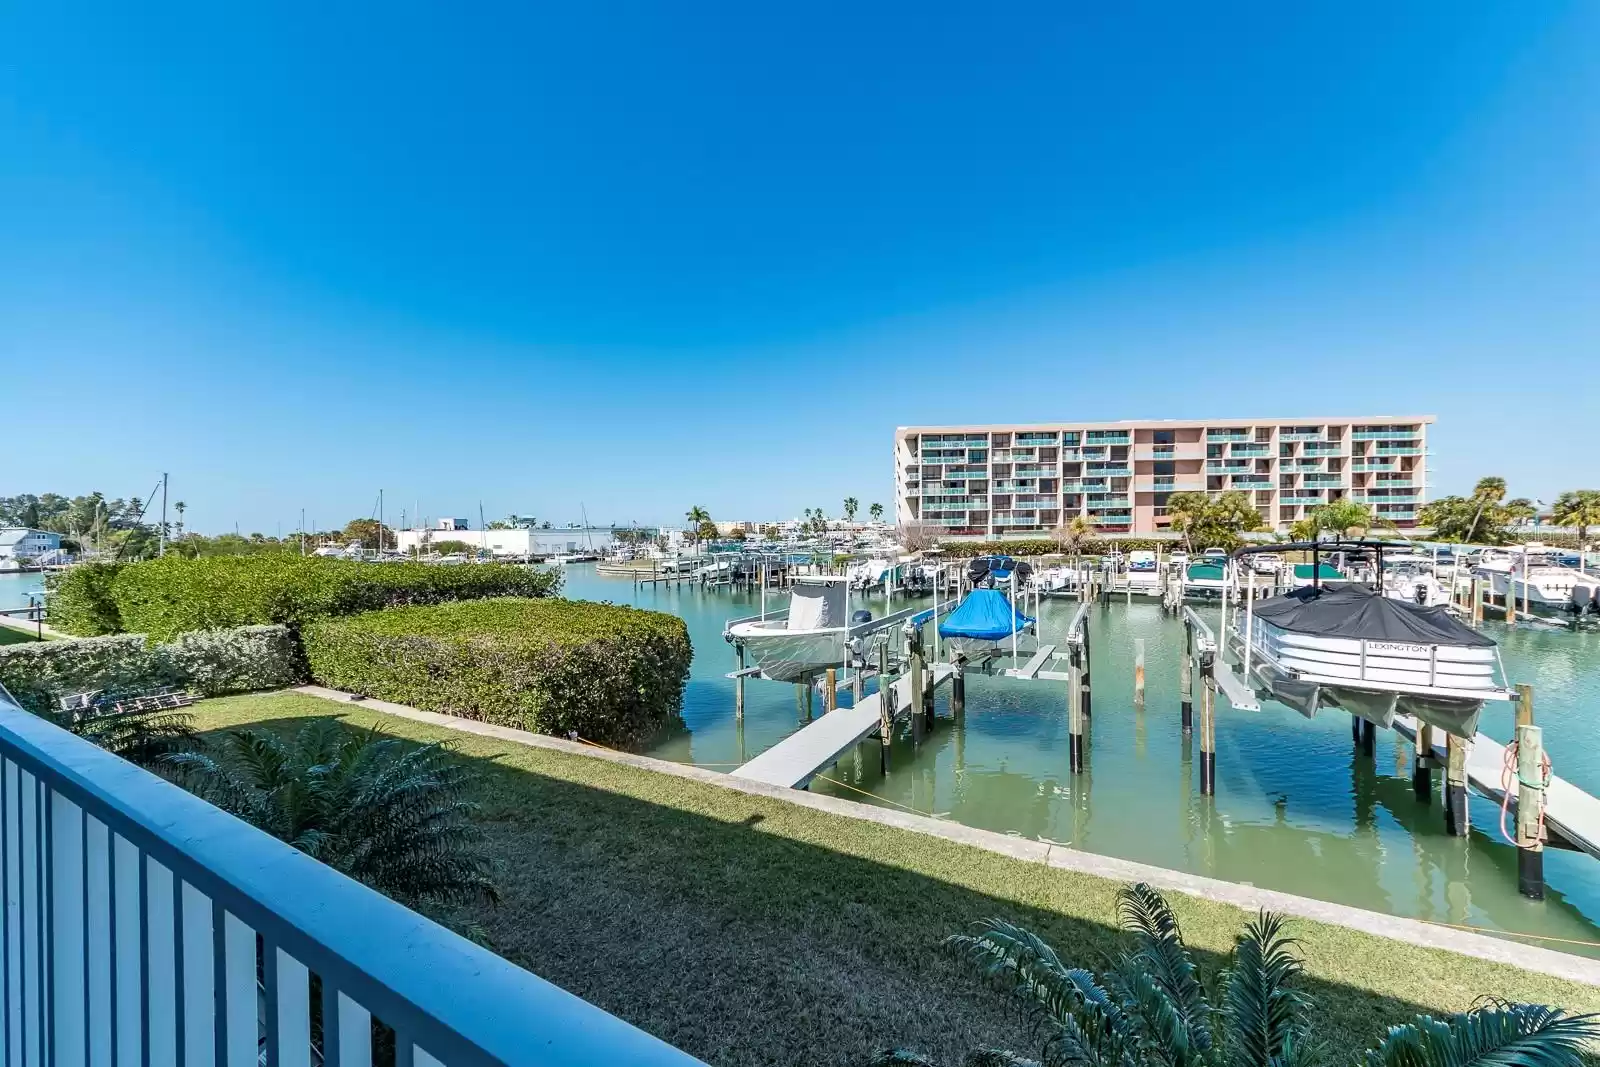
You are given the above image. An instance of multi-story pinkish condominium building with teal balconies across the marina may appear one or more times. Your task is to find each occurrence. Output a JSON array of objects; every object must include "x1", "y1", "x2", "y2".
[{"x1": 894, "y1": 414, "x2": 1434, "y2": 537}]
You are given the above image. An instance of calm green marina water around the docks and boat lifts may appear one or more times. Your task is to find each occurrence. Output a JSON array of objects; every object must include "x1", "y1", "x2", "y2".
[{"x1": 566, "y1": 566, "x2": 1600, "y2": 955}]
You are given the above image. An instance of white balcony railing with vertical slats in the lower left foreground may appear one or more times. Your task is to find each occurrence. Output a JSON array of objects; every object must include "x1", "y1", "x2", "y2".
[{"x1": 0, "y1": 689, "x2": 699, "y2": 1067}]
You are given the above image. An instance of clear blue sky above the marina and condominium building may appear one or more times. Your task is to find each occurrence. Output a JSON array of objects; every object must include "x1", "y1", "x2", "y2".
[{"x1": 0, "y1": 0, "x2": 1600, "y2": 534}]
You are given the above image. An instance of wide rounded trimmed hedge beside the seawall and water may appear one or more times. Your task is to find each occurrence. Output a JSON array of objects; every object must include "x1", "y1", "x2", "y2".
[{"x1": 301, "y1": 598, "x2": 693, "y2": 745}]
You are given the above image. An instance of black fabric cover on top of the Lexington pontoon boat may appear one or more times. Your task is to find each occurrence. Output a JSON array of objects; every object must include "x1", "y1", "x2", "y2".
[{"x1": 1256, "y1": 582, "x2": 1494, "y2": 648}]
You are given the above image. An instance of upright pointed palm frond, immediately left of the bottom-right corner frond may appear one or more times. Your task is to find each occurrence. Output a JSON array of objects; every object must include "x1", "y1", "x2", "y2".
[{"x1": 1222, "y1": 912, "x2": 1309, "y2": 1067}]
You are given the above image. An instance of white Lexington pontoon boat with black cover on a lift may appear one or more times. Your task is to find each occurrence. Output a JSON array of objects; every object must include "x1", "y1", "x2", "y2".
[{"x1": 1230, "y1": 582, "x2": 1515, "y2": 737}]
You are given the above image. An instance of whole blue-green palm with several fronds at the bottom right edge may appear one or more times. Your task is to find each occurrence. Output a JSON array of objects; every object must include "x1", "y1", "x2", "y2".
[{"x1": 874, "y1": 883, "x2": 1600, "y2": 1067}]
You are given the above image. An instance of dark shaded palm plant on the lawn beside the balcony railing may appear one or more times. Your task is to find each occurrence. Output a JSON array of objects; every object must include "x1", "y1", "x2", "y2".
[{"x1": 166, "y1": 720, "x2": 499, "y2": 907}]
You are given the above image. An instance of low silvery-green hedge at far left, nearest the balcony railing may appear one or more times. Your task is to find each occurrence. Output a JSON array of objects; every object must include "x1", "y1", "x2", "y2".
[{"x1": 0, "y1": 627, "x2": 306, "y2": 712}]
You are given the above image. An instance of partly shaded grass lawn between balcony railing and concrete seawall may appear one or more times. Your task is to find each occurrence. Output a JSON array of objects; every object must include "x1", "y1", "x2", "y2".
[{"x1": 197, "y1": 693, "x2": 1600, "y2": 1067}]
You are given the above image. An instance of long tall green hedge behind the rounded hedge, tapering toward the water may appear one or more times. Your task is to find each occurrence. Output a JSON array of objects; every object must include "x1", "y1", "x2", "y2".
[{"x1": 50, "y1": 555, "x2": 562, "y2": 640}]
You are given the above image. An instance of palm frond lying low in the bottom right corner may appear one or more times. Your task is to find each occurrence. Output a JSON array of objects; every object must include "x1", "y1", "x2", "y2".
[{"x1": 1366, "y1": 1003, "x2": 1600, "y2": 1067}]
